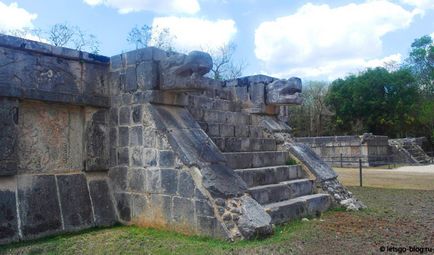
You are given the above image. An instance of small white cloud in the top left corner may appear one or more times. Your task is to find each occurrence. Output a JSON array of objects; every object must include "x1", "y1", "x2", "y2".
[{"x1": 0, "y1": 2, "x2": 38, "y2": 31}]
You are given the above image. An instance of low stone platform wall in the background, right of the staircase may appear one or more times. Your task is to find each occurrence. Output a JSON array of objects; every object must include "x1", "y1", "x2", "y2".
[{"x1": 294, "y1": 134, "x2": 390, "y2": 167}]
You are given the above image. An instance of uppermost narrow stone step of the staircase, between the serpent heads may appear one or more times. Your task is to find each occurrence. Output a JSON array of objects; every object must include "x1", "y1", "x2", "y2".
[{"x1": 188, "y1": 95, "x2": 241, "y2": 112}]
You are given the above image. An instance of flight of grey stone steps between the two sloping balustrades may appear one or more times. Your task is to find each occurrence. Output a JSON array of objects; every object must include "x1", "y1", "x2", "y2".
[{"x1": 189, "y1": 94, "x2": 331, "y2": 223}]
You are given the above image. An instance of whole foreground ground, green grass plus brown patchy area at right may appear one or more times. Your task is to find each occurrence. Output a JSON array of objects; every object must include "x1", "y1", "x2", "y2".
[{"x1": 0, "y1": 187, "x2": 434, "y2": 255}]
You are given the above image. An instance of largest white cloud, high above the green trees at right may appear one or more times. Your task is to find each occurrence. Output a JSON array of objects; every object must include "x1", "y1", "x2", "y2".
[{"x1": 255, "y1": 0, "x2": 416, "y2": 78}]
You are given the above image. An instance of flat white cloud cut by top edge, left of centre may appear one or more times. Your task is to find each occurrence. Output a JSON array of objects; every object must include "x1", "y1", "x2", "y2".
[{"x1": 84, "y1": 0, "x2": 200, "y2": 14}]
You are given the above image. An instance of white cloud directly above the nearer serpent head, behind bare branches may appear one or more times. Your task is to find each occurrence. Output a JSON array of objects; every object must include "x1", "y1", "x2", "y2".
[{"x1": 151, "y1": 17, "x2": 237, "y2": 51}]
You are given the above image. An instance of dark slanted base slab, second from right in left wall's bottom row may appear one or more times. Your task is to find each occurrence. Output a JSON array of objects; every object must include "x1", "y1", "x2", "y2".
[{"x1": 56, "y1": 174, "x2": 93, "y2": 231}]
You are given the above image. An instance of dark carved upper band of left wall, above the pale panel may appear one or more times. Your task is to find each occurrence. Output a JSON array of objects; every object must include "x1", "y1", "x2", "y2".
[{"x1": 0, "y1": 35, "x2": 109, "y2": 107}]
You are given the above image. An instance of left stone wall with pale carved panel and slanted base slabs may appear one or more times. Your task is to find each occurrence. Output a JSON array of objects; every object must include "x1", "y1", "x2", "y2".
[{"x1": 0, "y1": 36, "x2": 117, "y2": 243}]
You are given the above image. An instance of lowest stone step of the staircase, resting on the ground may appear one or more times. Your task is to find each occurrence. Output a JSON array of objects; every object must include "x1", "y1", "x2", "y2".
[{"x1": 264, "y1": 194, "x2": 332, "y2": 224}]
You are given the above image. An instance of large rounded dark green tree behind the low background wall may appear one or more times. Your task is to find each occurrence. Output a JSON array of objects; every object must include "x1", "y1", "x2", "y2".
[{"x1": 326, "y1": 67, "x2": 420, "y2": 137}]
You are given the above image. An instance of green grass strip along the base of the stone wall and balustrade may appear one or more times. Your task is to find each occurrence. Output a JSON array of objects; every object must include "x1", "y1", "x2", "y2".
[{"x1": 0, "y1": 221, "x2": 309, "y2": 254}]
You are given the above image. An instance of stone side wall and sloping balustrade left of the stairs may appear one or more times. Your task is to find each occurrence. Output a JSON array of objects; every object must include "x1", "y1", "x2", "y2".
[{"x1": 109, "y1": 48, "x2": 271, "y2": 240}]
